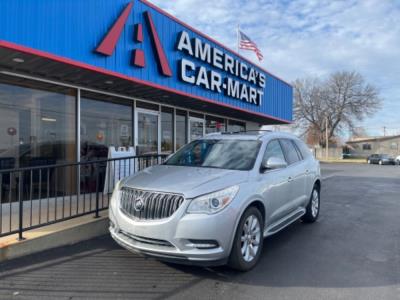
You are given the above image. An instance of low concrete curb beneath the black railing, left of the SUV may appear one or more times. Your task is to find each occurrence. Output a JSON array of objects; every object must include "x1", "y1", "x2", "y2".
[{"x1": 0, "y1": 216, "x2": 109, "y2": 262}]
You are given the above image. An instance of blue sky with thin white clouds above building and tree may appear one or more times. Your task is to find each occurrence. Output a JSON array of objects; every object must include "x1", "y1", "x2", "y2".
[{"x1": 152, "y1": 0, "x2": 400, "y2": 135}]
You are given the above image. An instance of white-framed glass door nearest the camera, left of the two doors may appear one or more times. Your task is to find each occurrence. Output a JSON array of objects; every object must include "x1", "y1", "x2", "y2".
[{"x1": 135, "y1": 109, "x2": 160, "y2": 155}]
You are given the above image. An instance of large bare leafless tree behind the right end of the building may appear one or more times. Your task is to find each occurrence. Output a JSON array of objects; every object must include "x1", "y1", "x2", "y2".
[{"x1": 293, "y1": 71, "x2": 382, "y2": 146}]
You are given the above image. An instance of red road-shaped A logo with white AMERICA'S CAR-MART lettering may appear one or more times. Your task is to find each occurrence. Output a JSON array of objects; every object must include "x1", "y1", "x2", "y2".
[{"x1": 95, "y1": 2, "x2": 266, "y2": 105}]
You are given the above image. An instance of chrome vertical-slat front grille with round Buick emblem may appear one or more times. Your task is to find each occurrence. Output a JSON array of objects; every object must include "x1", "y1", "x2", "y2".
[{"x1": 120, "y1": 187, "x2": 184, "y2": 220}]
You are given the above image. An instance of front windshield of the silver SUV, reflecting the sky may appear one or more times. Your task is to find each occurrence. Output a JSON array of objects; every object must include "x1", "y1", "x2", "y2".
[{"x1": 165, "y1": 139, "x2": 261, "y2": 171}]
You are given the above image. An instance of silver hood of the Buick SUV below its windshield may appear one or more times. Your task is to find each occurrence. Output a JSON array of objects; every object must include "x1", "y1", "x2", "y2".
[{"x1": 123, "y1": 165, "x2": 249, "y2": 198}]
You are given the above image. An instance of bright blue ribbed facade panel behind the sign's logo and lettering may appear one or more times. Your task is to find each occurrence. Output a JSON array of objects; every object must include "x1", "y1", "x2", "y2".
[{"x1": 0, "y1": 0, "x2": 293, "y2": 122}]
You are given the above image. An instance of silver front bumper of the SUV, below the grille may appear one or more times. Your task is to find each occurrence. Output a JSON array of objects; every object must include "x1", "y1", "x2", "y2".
[{"x1": 109, "y1": 201, "x2": 236, "y2": 266}]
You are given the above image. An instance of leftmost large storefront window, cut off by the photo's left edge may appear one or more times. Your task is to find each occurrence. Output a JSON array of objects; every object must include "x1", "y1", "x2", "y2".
[{"x1": 0, "y1": 77, "x2": 76, "y2": 169}]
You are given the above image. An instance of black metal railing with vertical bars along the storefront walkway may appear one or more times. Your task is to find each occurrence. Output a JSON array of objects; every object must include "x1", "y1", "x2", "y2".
[{"x1": 0, "y1": 155, "x2": 167, "y2": 240}]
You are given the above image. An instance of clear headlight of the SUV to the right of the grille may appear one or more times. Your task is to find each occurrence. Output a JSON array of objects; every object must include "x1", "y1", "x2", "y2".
[{"x1": 187, "y1": 185, "x2": 239, "y2": 214}]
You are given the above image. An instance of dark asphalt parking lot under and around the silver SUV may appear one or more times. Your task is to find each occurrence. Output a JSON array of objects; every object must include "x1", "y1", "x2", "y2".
[{"x1": 0, "y1": 164, "x2": 400, "y2": 299}]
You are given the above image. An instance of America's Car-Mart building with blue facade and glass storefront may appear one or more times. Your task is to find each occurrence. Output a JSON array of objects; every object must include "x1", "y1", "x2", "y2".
[{"x1": 0, "y1": 0, "x2": 292, "y2": 169}]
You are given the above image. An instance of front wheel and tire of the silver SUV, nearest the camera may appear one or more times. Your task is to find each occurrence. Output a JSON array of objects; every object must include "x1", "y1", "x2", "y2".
[{"x1": 228, "y1": 206, "x2": 264, "y2": 272}]
